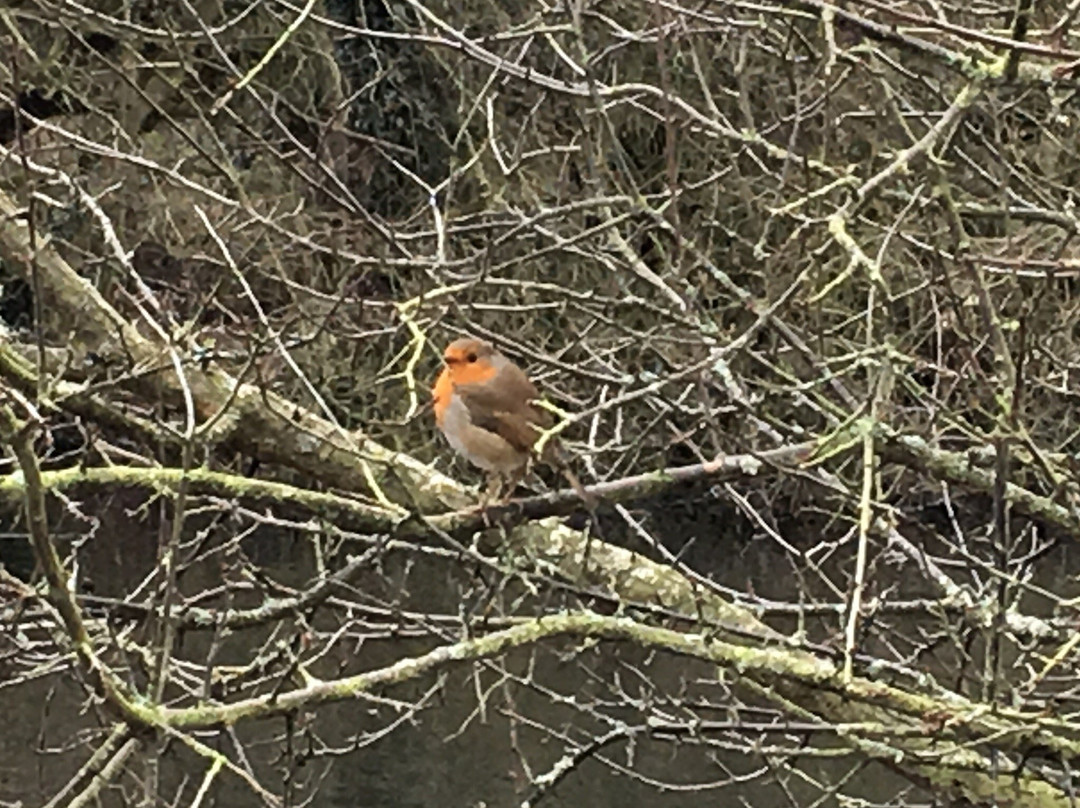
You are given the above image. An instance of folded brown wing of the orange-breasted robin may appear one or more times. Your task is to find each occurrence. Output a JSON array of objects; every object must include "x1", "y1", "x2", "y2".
[{"x1": 455, "y1": 363, "x2": 551, "y2": 452}]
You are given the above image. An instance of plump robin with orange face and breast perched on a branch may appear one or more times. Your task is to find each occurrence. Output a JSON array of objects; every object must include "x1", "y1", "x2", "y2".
[{"x1": 431, "y1": 337, "x2": 590, "y2": 501}]
